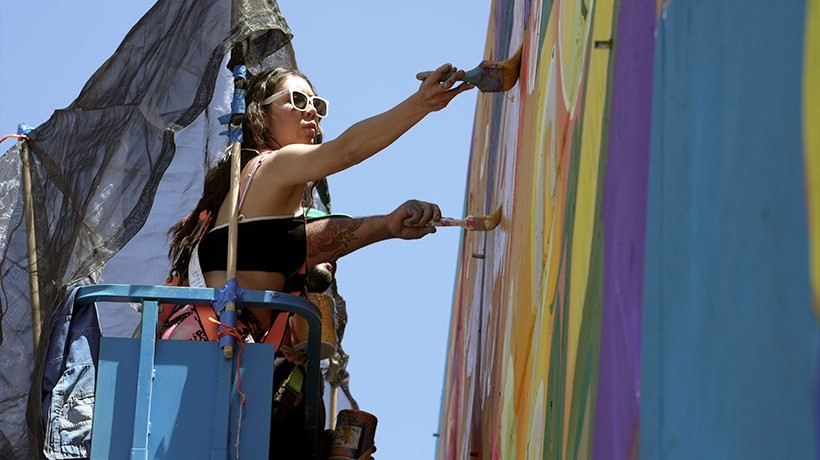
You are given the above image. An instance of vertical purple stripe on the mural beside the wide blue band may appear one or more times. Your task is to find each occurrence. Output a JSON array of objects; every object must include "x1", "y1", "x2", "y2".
[{"x1": 593, "y1": 0, "x2": 655, "y2": 459}]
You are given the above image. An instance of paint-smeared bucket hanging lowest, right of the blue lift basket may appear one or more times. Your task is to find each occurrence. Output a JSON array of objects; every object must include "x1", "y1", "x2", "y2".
[{"x1": 329, "y1": 409, "x2": 377, "y2": 460}]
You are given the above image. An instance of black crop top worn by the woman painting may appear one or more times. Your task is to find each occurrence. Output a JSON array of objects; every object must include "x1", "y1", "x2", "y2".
[{"x1": 199, "y1": 215, "x2": 307, "y2": 279}]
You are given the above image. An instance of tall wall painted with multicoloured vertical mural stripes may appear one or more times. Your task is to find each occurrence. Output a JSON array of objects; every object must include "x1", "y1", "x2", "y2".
[{"x1": 438, "y1": 0, "x2": 820, "y2": 459}]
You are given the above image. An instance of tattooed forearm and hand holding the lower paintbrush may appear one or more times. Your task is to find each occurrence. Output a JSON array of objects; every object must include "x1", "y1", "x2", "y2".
[{"x1": 307, "y1": 200, "x2": 441, "y2": 265}]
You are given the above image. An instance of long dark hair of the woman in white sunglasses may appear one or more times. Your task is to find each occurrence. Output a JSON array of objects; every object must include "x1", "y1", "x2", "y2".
[{"x1": 168, "y1": 67, "x2": 313, "y2": 282}]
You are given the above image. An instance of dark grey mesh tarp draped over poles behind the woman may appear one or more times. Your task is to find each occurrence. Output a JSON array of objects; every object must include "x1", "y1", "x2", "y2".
[{"x1": 0, "y1": 0, "x2": 295, "y2": 458}]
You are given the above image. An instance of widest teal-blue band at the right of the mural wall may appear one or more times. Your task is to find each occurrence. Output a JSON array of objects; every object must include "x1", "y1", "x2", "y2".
[{"x1": 641, "y1": 0, "x2": 820, "y2": 459}]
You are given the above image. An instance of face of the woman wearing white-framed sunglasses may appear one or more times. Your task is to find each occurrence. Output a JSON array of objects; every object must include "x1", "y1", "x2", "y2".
[{"x1": 265, "y1": 75, "x2": 319, "y2": 147}]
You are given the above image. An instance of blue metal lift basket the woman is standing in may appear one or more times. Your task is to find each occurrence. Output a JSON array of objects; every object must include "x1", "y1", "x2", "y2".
[{"x1": 75, "y1": 284, "x2": 322, "y2": 460}]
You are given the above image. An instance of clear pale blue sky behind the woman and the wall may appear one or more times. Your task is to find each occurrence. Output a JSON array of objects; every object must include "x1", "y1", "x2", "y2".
[{"x1": 0, "y1": 0, "x2": 490, "y2": 460}]
